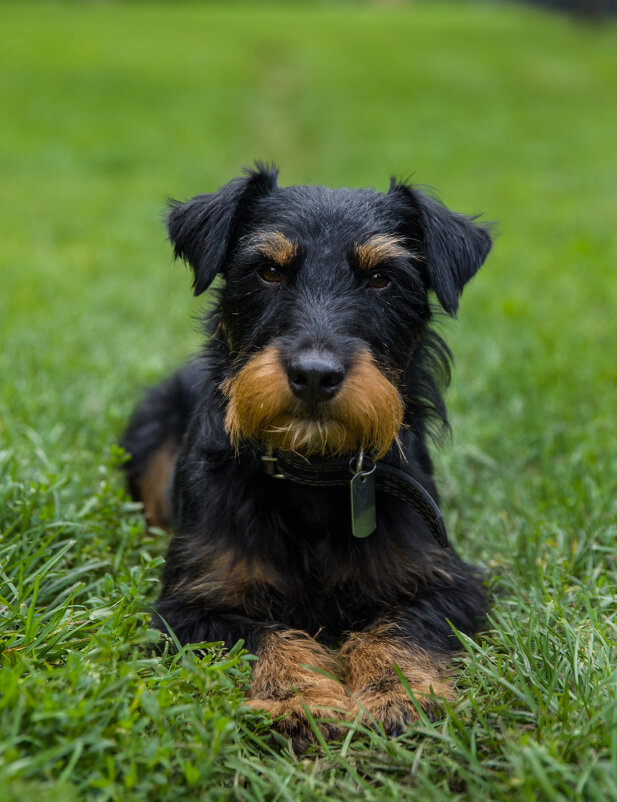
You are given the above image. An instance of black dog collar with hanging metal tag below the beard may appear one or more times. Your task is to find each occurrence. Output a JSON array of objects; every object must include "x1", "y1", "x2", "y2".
[{"x1": 261, "y1": 450, "x2": 448, "y2": 548}]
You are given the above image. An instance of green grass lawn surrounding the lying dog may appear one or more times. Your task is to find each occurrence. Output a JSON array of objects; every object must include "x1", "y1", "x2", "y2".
[{"x1": 0, "y1": 2, "x2": 617, "y2": 802}]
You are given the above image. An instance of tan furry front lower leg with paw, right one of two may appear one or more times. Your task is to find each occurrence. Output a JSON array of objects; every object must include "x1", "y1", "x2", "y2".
[{"x1": 341, "y1": 621, "x2": 454, "y2": 735}]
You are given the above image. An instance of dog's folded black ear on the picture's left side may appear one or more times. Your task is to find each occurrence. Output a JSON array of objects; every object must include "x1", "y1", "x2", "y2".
[{"x1": 167, "y1": 162, "x2": 278, "y2": 295}]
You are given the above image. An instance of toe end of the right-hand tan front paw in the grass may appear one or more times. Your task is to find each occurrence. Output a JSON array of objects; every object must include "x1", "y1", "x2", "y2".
[{"x1": 353, "y1": 687, "x2": 436, "y2": 736}]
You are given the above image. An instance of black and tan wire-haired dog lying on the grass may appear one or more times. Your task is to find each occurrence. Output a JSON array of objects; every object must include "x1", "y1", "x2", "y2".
[{"x1": 122, "y1": 163, "x2": 491, "y2": 748}]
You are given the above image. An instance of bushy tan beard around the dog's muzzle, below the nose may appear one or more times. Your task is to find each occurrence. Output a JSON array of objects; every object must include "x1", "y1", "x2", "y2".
[{"x1": 222, "y1": 346, "x2": 403, "y2": 458}]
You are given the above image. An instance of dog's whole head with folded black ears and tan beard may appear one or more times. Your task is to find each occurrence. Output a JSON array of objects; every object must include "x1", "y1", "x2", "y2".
[{"x1": 168, "y1": 168, "x2": 490, "y2": 457}]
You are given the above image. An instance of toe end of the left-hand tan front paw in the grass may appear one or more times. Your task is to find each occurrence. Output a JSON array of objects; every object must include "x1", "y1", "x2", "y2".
[{"x1": 246, "y1": 695, "x2": 350, "y2": 752}]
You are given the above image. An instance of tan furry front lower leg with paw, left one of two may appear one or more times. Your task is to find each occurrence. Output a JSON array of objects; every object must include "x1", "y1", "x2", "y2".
[{"x1": 249, "y1": 629, "x2": 350, "y2": 750}]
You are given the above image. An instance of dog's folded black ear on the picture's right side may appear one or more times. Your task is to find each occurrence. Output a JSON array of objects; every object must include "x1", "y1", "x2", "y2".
[{"x1": 388, "y1": 179, "x2": 492, "y2": 315}]
